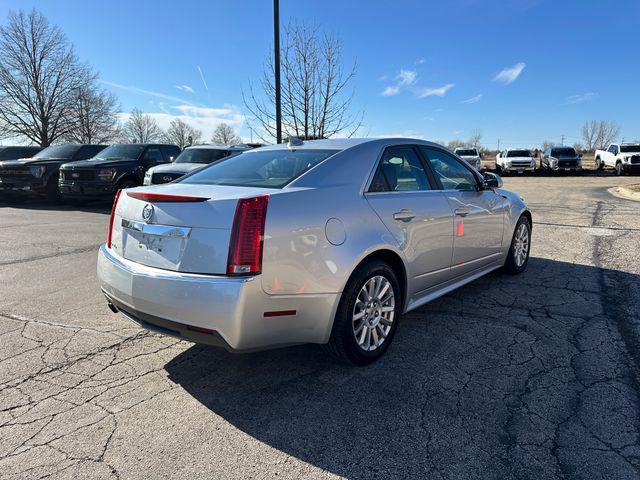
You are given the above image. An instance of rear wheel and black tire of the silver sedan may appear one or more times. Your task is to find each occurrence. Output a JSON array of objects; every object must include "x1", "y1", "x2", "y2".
[{"x1": 324, "y1": 260, "x2": 402, "y2": 365}]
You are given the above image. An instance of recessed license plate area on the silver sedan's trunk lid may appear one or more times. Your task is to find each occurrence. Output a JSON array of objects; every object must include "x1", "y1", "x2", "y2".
[{"x1": 122, "y1": 219, "x2": 191, "y2": 269}]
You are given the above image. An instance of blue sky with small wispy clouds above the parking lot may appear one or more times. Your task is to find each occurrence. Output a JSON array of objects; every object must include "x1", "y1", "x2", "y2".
[{"x1": 0, "y1": 0, "x2": 640, "y2": 148}]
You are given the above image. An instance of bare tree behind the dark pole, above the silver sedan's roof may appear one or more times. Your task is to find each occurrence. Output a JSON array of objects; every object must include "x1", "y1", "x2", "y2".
[{"x1": 243, "y1": 23, "x2": 362, "y2": 141}]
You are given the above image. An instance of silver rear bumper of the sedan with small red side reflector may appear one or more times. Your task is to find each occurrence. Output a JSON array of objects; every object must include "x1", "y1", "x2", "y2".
[{"x1": 98, "y1": 245, "x2": 340, "y2": 351}]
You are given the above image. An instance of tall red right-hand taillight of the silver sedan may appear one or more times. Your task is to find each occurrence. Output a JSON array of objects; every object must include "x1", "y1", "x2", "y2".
[{"x1": 227, "y1": 195, "x2": 269, "y2": 275}]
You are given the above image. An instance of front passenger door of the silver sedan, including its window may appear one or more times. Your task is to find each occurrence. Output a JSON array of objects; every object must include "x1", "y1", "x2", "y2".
[{"x1": 420, "y1": 147, "x2": 507, "y2": 277}]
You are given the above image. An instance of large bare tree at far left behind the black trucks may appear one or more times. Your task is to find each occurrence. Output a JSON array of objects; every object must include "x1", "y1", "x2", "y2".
[{"x1": 0, "y1": 10, "x2": 96, "y2": 146}]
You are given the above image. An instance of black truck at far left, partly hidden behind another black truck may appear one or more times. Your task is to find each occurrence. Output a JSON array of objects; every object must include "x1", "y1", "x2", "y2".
[{"x1": 0, "y1": 144, "x2": 106, "y2": 202}]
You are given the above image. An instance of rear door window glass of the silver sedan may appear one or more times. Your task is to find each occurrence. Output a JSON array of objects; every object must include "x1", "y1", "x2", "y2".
[{"x1": 369, "y1": 147, "x2": 431, "y2": 192}]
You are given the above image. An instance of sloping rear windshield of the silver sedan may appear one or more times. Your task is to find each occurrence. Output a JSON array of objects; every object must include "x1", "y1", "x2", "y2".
[{"x1": 182, "y1": 150, "x2": 338, "y2": 188}]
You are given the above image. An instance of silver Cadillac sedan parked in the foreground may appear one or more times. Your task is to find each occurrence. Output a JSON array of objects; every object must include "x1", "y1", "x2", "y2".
[{"x1": 98, "y1": 138, "x2": 532, "y2": 365}]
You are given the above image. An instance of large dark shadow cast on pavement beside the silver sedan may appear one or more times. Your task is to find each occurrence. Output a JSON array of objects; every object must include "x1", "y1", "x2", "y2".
[{"x1": 165, "y1": 258, "x2": 640, "y2": 479}]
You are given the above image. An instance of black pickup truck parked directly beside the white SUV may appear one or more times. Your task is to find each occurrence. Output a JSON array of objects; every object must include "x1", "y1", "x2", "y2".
[{"x1": 58, "y1": 143, "x2": 180, "y2": 203}]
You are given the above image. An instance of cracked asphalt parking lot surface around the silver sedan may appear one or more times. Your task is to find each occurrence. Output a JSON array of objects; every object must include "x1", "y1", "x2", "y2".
[{"x1": 0, "y1": 176, "x2": 640, "y2": 479}]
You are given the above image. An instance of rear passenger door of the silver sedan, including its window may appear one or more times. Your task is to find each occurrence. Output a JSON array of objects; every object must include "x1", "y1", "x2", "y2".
[{"x1": 365, "y1": 145, "x2": 453, "y2": 295}]
